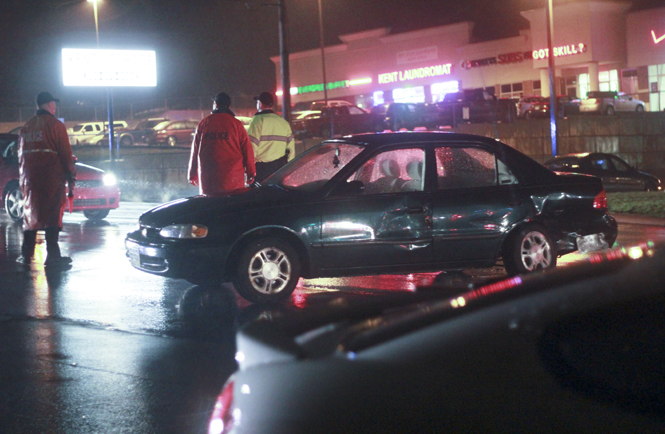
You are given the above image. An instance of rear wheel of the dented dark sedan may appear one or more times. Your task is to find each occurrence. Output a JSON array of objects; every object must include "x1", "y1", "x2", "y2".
[{"x1": 503, "y1": 224, "x2": 556, "y2": 276}]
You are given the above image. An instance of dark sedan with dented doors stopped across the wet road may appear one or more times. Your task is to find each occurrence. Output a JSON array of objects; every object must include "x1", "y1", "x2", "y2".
[{"x1": 125, "y1": 132, "x2": 617, "y2": 302}]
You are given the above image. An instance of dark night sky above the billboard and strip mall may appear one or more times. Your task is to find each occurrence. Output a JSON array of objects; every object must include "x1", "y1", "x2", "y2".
[{"x1": 0, "y1": 0, "x2": 662, "y2": 107}]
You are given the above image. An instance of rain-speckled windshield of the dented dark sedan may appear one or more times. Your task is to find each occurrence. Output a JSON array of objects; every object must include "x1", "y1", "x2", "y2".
[{"x1": 267, "y1": 142, "x2": 364, "y2": 191}]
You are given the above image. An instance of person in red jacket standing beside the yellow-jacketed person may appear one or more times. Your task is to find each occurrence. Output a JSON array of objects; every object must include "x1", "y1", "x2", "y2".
[{"x1": 188, "y1": 92, "x2": 256, "y2": 195}]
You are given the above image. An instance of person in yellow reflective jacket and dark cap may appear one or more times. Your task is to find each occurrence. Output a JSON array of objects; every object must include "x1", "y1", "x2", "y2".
[{"x1": 247, "y1": 92, "x2": 296, "y2": 182}]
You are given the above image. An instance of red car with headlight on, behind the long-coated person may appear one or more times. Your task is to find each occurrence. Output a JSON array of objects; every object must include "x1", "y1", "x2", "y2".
[{"x1": 0, "y1": 134, "x2": 120, "y2": 221}]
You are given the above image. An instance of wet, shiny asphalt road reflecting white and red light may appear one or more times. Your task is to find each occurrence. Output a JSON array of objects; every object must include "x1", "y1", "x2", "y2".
[{"x1": 0, "y1": 202, "x2": 665, "y2": 434}]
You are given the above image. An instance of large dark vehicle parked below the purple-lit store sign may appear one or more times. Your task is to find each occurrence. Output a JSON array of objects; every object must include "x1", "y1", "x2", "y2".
[{"x1": 437, "y1": 89, "x2": 517, "y2": 126}]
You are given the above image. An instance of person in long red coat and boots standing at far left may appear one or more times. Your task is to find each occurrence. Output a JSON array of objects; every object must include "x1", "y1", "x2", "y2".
[{"x1": 16, "y1": 92, "x2": 76, "y2": 266}]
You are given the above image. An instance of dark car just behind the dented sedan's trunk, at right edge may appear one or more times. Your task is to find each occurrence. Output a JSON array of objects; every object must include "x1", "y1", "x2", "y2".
[{"x1": 545, "y1": 152, "x2": 663, "y2": 191}]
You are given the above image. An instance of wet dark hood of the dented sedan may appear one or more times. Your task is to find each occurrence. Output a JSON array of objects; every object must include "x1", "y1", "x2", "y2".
[{"x1": 139, "y1": 185, "x2": 310, "y2": 228}]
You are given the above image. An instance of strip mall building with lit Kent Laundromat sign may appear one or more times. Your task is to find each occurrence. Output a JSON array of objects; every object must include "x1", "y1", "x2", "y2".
[{"x1": 272, "y1": 0, "x2": 665, "y2": 111}]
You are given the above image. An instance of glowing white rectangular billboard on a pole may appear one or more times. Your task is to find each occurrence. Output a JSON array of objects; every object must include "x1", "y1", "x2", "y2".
[{"x1": 62, "y1": 48, "x2": 157, "y2": 87}]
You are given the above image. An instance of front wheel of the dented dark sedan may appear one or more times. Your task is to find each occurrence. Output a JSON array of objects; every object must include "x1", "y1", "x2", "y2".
[{"x1": 233, "y1": 238, "x2": 300, "y2": 303}]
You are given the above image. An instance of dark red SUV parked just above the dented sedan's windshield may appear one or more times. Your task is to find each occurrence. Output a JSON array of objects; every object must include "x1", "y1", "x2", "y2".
[{"x1": 291, "y1": 105, "x2": 381, "y2": 138}]
